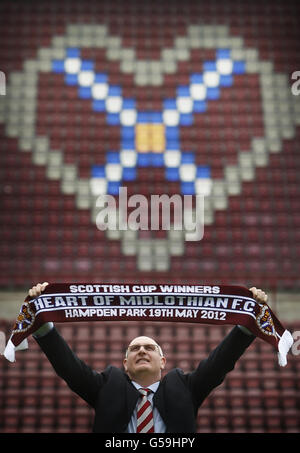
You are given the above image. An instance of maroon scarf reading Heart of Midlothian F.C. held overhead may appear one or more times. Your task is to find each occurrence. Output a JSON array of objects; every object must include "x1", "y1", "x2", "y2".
[{"x1": 4, "y1": 283, "x2": 293, "y2": 366}]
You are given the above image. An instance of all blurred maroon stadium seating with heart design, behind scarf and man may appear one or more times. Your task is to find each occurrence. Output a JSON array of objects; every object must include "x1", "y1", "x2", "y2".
[{"x1": 0, "y1": 0, "x2": 300, "y2": 433}]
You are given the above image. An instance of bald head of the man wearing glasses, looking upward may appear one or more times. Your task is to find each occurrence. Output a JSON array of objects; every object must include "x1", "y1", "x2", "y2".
[{"x1": 123, "y1": 337, "x2": 166, "y2": 386}]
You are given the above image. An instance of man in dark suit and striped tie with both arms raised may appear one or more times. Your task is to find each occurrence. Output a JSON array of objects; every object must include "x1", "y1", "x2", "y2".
[{"x1": 29, "y1": 282, "x2": 267, "y2": 433}]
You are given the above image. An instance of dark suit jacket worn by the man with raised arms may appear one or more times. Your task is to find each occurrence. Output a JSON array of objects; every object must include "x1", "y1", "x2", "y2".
[{"x1": 36, "y1": 327, "x2": 255, "y2": 433}]
